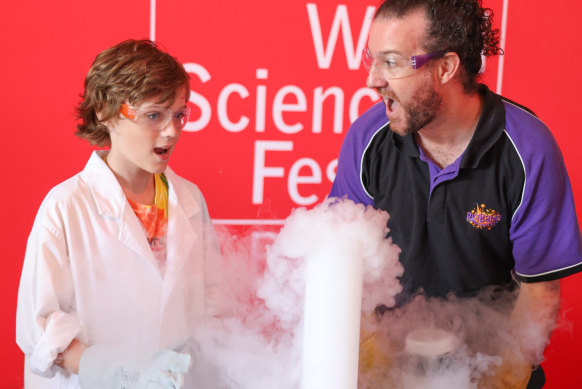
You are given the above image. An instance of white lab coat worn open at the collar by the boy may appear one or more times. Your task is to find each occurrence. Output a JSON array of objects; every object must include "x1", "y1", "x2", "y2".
[{"x1": 16, "y1": 151, "x2": 218, "y2": 389}]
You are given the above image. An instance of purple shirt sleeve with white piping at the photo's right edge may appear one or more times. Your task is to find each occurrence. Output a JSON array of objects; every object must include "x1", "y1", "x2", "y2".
[{"x1": 505, "y1": 102, "x2": 582, "y2": 282}]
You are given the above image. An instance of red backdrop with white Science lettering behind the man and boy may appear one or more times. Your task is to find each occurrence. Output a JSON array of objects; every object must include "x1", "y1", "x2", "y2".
[{"x1": 0, "y1": 0, "x2": 582, "y2": 389}]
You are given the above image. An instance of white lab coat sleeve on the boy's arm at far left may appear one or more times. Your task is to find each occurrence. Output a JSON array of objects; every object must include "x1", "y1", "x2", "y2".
[{"x1": 16, "y1": 199, "x2": 80, "y2": 377}]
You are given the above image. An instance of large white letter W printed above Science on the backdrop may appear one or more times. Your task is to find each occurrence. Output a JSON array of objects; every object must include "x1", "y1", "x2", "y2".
[{"x1": 307, "y1": 3, "x2": 375, "y2": 69}]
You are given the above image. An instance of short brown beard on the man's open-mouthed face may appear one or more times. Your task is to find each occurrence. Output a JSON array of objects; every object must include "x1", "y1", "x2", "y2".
[{"x1": 390, "y1": 84, "x2": 443, "y2": 136}]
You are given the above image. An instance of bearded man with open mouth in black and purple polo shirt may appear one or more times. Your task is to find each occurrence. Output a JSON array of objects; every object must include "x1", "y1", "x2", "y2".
[{"x1": 330, "y1": 0, "x2": 582, "y2": 388}]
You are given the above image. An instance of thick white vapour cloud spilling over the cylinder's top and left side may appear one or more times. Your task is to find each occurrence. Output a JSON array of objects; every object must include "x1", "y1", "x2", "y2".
[{"x1": 193, "y1": 200, "x2": 403, "y2": 389}]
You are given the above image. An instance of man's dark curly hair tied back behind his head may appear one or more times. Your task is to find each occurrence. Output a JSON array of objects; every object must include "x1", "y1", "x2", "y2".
[{"x1": 374, "y1": 0, "x2": 503, "y2": 93}]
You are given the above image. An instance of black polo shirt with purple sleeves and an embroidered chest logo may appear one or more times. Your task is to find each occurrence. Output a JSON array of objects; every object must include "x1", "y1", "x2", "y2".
[{"x1": 330, "y1": 86, "x2": 582, "y2": 296}]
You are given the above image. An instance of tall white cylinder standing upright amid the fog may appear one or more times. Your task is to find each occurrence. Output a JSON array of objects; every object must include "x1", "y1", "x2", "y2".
[{"x1": 301, "y1": 246, "x2": 363, "y2": 389}]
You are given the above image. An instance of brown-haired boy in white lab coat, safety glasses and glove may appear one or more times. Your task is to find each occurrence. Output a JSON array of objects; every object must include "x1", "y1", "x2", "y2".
[{"x1": 16, "y1": 40, "x2": 218, "y2": 388}]
